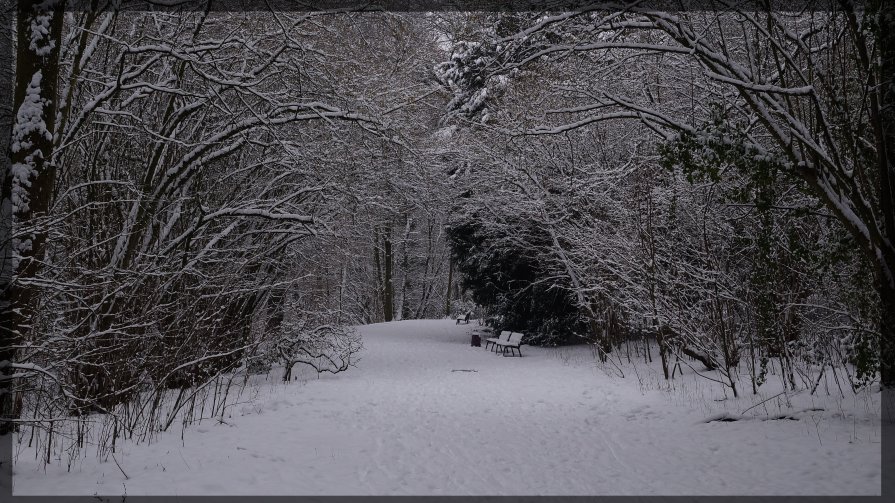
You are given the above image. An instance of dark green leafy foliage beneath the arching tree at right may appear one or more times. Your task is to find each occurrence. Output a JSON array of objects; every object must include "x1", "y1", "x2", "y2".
[{"x1": 659, "y1": 104, "x2": 880, "y2": 388}]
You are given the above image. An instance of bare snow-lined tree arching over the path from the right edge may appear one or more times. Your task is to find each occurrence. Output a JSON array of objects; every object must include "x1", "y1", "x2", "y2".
[{"x1": 438, "y1": 2, "x2": 895, "y2": 384}]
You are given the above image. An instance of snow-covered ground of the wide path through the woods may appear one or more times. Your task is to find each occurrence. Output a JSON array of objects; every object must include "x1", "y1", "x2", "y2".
[{"x1": 13, "y1": 320, "x2": 881, "y2": 495}]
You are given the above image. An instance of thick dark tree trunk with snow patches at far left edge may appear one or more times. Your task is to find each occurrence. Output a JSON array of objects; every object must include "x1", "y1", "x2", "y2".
[{"x1": 0, "y1": 0, "x2": 65, "y2": 434}]
